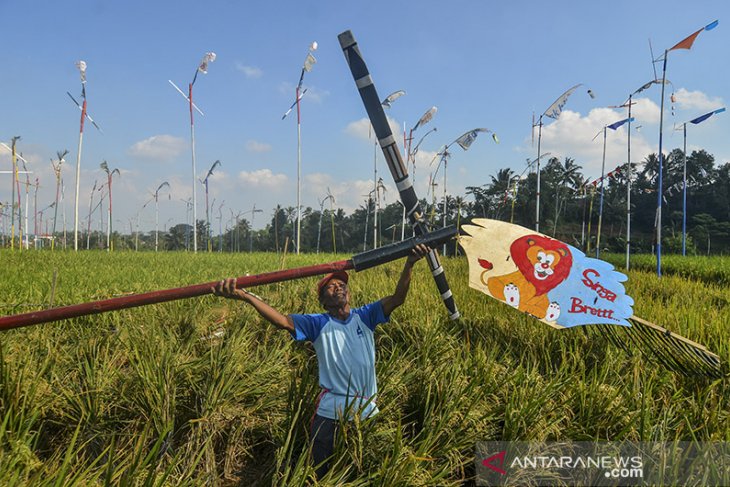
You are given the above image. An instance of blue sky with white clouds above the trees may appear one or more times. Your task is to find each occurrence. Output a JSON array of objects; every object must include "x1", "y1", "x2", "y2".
[{"x1": 0, "y1": 0, "x2": 730, "y2": 233}]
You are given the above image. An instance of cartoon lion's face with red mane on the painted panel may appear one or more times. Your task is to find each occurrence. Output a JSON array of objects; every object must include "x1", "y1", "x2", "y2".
[{"x1": 510, "y1": 235, "x2": 573, "y2": 296}]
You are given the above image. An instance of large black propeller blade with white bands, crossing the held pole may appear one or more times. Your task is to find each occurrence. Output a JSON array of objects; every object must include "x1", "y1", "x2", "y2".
[{"x1": 337, "y1": 30, "x2": 459, "y2": 320}]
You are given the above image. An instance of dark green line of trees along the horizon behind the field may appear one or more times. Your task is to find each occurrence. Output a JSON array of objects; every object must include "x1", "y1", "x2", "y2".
[{"x1": 45, "y1": 149, "x2": 730, "y2": 254}]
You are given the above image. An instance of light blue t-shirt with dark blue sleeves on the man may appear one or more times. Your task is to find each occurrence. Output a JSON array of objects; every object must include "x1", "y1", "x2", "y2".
[{"x1": 290, "y1": 301, "x2": 389, "y2": 419}]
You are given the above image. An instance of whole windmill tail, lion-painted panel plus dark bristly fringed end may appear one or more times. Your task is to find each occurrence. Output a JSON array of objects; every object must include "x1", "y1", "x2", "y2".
[{"x1": 459, "y1": 218, "x2": 726, "y2": 378}]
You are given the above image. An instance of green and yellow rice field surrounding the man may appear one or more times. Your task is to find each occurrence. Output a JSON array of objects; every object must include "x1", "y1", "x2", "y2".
[{"x1": 0, "y1": 250, "x2": 730, "y2": 486}]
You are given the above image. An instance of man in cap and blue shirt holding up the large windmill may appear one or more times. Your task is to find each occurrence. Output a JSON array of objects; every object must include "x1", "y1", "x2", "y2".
[{"x1": 213, "y1": 244, "x2": 429, "y2": 477}]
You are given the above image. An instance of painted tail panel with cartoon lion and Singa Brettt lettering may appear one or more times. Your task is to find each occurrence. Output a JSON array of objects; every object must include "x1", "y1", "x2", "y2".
[{"x1": 459, "y1": 218, "x2": 634, "y2": 328}]
